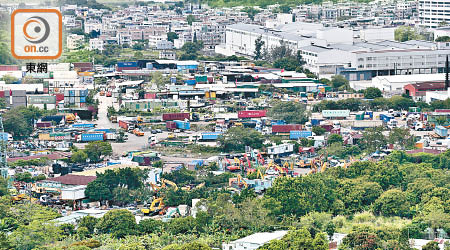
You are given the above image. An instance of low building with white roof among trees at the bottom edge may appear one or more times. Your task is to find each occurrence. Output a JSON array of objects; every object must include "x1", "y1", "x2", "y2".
[{"x1": 222, "y1": 231, "x2": 288, "y2": 250}]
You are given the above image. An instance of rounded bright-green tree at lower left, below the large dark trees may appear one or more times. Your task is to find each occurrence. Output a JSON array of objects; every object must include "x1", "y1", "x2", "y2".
[{"x1": 97, "y1": 209, "x2": 137, "y2": 238}]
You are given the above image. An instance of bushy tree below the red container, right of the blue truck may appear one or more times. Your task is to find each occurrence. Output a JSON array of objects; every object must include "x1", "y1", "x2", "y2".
[{"x1": 219, "y1": 127, "x2": 264, "y2": 152}]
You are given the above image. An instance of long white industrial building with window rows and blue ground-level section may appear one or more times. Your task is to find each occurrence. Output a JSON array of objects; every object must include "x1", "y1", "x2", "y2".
[{"x1": 300, "y1": 40, "x2": 450, "y2": 81}]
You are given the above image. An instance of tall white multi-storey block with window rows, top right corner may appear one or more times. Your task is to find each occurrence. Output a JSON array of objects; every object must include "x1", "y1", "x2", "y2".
[{"x1": 418, "y1": 0, "x2": 450, "y2": 28}]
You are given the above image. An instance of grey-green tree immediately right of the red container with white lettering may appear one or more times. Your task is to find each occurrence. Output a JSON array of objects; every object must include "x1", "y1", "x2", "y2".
[{"x1": 268, "y1": 102, "x2": 309, "y2": 124}]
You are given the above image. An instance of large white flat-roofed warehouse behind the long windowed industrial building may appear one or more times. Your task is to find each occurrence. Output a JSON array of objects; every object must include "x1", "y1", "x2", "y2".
[{"x1": 216, "y1": 22, "x2": 353, "y2": 56}]
